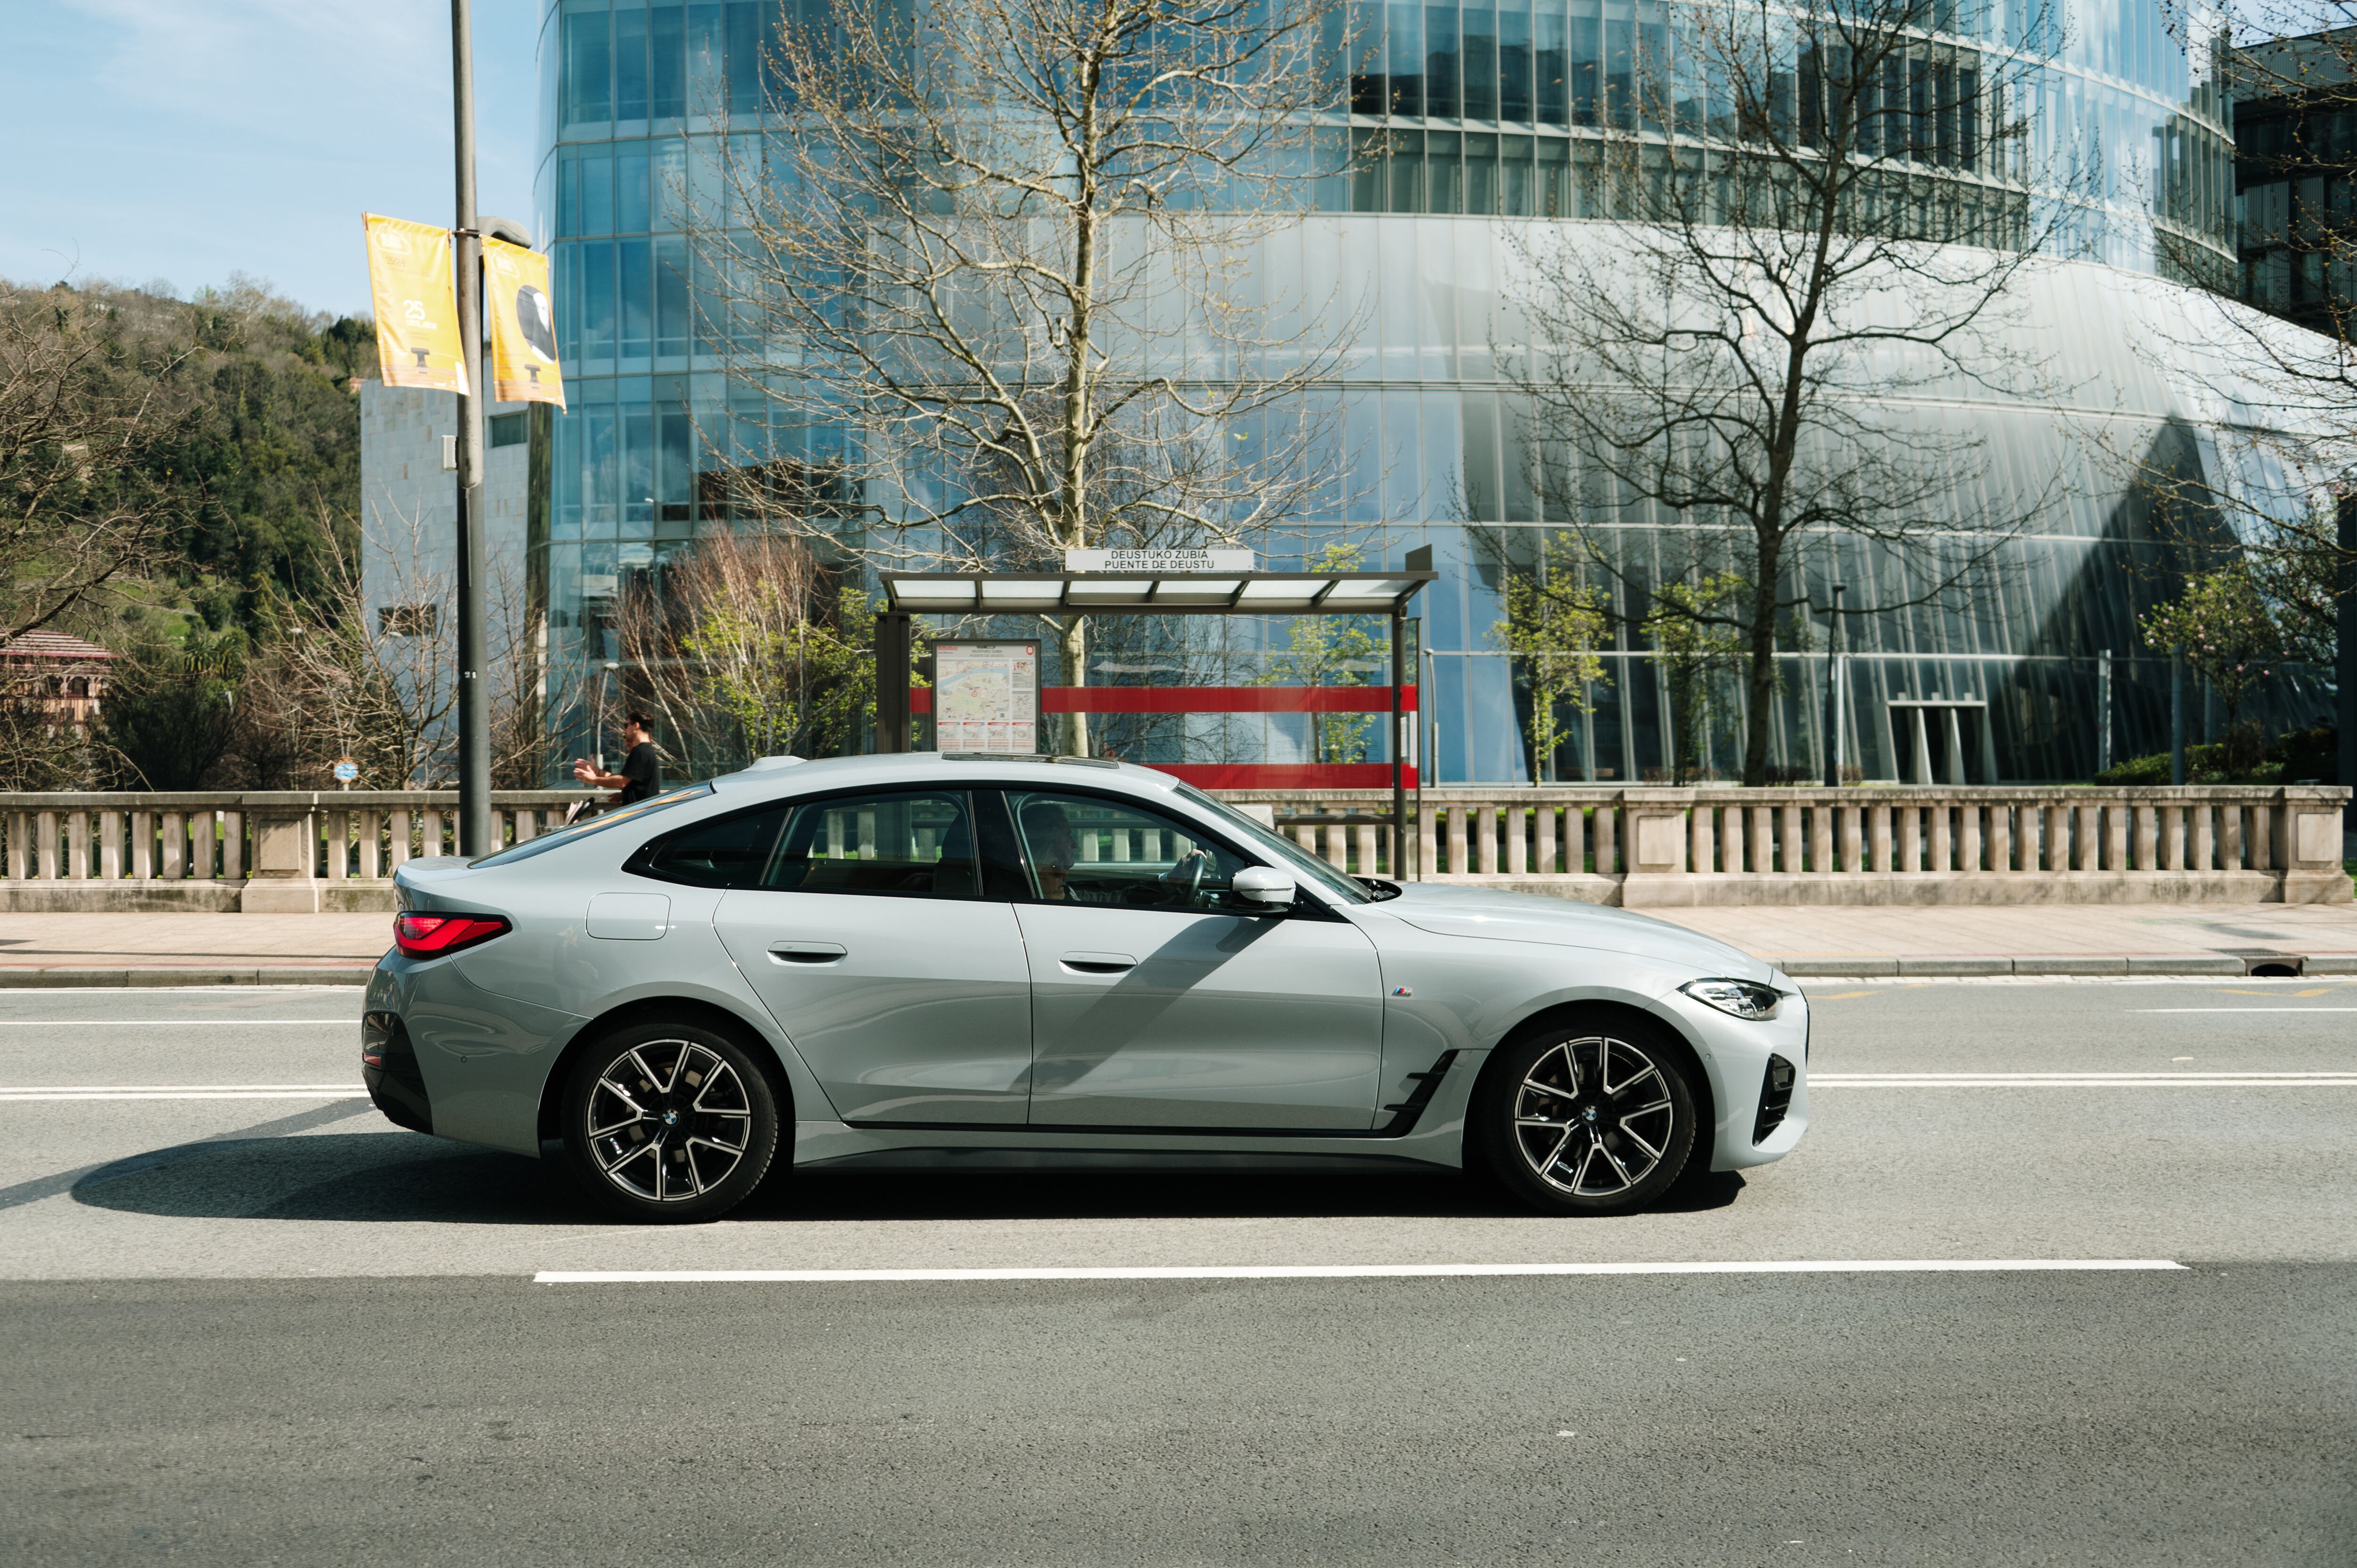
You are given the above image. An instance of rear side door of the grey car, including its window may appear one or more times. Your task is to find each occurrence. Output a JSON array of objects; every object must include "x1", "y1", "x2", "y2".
[{"x1": 658, "y1": 788, "x2": 1032, "y2": 1125}]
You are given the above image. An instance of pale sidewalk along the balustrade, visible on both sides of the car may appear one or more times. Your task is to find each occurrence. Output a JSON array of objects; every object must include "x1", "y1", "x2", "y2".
[{"x1": 0, "y1": 903, "x2": 2357, "y2": 985}]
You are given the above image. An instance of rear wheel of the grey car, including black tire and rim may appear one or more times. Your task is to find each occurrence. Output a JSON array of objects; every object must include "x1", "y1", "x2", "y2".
[{"x1": 561, "y1": 1023, "x2": 778, "y2": 1224}]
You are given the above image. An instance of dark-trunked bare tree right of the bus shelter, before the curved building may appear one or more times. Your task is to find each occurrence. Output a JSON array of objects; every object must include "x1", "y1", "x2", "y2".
[{"x1": 1501, "y1": 0, "x2": 2062, "y2": 785}]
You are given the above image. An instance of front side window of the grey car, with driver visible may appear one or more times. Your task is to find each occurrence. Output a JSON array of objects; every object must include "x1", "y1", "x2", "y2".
[{"x1": 1006, "y1": 790, "x2": 1266, "y2": 912}]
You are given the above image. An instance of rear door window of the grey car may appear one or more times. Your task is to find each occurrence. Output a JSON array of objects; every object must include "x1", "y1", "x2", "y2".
[{"x1": 759, "y1": 790, "x2": 983, "y2": 898}]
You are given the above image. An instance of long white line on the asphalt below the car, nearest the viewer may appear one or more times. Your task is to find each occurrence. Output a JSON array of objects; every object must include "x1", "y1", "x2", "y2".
[{"x1": 533, "y1": 1257, "x2": 2185, "y2": 1285}]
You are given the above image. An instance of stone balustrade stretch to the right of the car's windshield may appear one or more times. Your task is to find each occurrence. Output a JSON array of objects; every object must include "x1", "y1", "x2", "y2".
[{"x1": 1221, "y1": 785, "x2": 2350, "y2": 908}]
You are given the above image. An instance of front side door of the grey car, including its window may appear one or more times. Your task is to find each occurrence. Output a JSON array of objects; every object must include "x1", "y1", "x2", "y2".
[{"x1": 1006, "y1": 790, "x2": 1384, "y2": 1129}]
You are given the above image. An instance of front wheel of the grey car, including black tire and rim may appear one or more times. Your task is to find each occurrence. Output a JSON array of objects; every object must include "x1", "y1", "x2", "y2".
[{"x1": 1471, "y1": 1014, "x2": 1697, "y2": 1215}]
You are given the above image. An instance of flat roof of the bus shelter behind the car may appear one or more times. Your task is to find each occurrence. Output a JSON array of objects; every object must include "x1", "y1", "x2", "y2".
[{"x1": 879, "y1": 571, "x2": 1440, "y2": 616}]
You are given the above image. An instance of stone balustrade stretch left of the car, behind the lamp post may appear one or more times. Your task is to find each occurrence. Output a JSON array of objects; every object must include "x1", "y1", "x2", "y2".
[{"x1": 0, "y1": 790, "x2": 599, "y2": 915}]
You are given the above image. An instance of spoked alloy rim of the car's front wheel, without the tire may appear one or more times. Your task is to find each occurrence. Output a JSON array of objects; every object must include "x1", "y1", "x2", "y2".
[{"x1": 1513, "y1": 1035, "x2": 1678, "y2": 1198}]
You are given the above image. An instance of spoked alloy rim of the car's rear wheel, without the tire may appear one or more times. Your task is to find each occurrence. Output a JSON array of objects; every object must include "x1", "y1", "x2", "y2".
[{"x1": 587, "y1": 1040, "x2": 752, "y2": 1203}]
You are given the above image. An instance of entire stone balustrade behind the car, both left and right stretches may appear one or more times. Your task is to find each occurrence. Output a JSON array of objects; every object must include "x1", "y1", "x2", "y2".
[{"x1": 0, "y1": 785, "x2": 2350, "y2": 912}]
